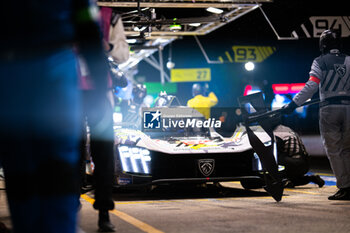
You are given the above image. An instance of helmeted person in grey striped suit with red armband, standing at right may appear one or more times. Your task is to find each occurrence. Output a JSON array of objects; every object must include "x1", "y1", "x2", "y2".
[{"x1": 283, "y1": 30, "x2": 350, "y2": 200}]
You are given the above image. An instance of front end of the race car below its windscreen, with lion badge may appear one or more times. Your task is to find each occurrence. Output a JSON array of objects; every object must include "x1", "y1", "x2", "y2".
[{"x1": 116, "y1": 120, "x2": 269, "y2": 185}]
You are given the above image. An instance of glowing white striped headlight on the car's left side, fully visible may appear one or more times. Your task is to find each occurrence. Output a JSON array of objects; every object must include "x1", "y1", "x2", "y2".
[{"x1": 119, "y1": 146, "x2": 151, "y2": 174}]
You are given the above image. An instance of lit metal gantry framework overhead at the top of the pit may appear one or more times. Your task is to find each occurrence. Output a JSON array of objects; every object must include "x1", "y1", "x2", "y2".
[{"x1": 98, "y1": 0, "x2": 273, "y2": 79}]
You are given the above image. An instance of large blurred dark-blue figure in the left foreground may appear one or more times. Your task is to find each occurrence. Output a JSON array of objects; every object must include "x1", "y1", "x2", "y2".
[{"x1": 0, "y1": 0, "x2": 107, "y2": 233}]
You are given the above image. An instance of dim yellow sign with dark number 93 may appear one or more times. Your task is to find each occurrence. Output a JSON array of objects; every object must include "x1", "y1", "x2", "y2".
[{"x1": 232, "y1": 46, "x2": 276, "y2": 62}]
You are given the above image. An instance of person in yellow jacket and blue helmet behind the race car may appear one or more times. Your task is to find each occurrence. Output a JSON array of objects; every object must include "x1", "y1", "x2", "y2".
[{"x1": 187, "y1": 83, "x2": 218, "y2": 119}]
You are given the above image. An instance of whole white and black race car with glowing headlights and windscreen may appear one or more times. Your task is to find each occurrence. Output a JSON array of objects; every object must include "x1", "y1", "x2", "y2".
[{"x1": 115, "y1": 92, "x2": 283, "y2": 199}]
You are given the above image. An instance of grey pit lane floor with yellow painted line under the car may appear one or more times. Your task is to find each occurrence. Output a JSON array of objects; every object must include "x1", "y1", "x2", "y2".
[{"x1": 0, "y1": 157, "x2": 350, "y2": 233}]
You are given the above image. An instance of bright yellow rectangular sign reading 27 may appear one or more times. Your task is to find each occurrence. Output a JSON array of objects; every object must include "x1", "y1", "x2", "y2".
[{"x1": 170, "y1": 68, "x2": 211, "y2": 82}]
